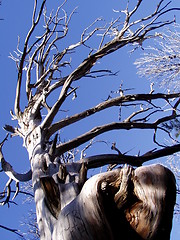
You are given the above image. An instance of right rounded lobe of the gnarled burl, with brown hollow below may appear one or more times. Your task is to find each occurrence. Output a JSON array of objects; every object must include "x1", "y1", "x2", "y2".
[{"x1": 126, "y1": 164, "x2": 176, "y2": 240}]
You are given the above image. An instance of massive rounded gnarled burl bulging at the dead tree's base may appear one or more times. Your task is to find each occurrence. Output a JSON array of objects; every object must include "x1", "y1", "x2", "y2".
[{"x1": 38, "y1": 165, "x2": 176, "y2": 240}]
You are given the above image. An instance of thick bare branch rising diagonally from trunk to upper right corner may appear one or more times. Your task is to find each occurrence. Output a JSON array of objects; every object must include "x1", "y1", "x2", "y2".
[{"x1": 41, "y1": 1, "x2": 179, "y2": 128}]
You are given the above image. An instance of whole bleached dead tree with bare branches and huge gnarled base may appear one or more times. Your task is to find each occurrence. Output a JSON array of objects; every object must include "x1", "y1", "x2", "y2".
[{"x1": 1, "y1": 0, "x2": 180, "y2": 240}]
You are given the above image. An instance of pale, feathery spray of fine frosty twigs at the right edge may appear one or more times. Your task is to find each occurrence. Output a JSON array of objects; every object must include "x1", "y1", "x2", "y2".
[{"x1": 135, "y1": 24, "x2": 180, "y2": 91}]
